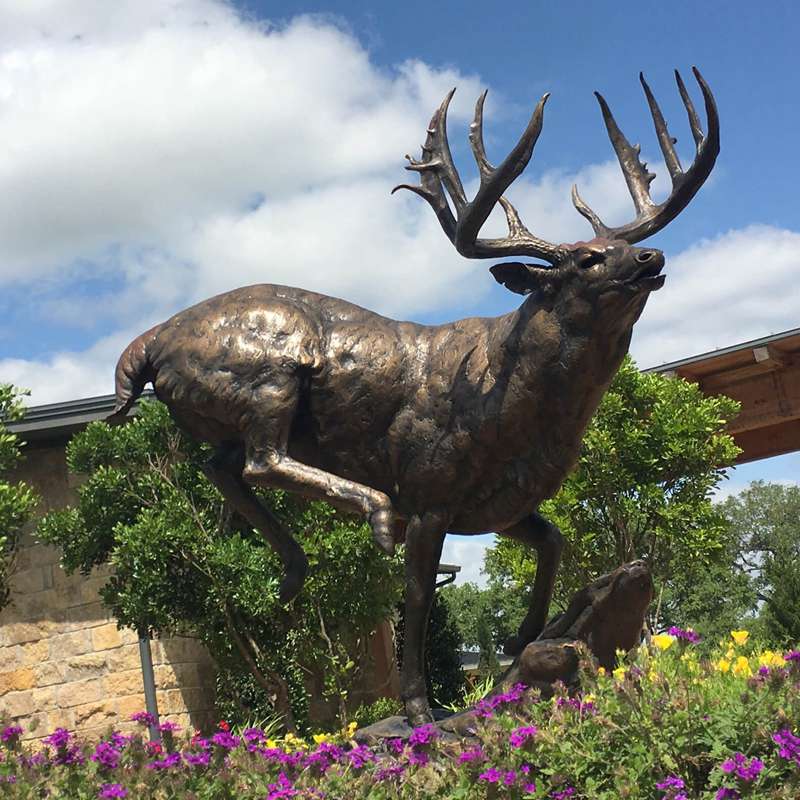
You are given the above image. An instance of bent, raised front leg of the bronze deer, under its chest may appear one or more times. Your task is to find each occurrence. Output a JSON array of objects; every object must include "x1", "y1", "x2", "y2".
[{"x1": 499, "y1": 512, "x2": 564, "y2": 656}]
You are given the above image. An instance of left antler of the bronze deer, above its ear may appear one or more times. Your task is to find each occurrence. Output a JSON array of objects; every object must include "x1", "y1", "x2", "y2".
[{"x1": 392, "y1": 89, "x2": 567, "y2": 264}]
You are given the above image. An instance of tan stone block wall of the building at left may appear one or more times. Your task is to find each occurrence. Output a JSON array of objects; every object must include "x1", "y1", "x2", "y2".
[{"x1": 0, "y1": 445, "x2": 213, "y2": 738}]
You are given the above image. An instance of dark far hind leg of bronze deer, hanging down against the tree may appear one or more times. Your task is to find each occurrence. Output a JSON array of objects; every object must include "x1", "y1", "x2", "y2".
[{"x1": 203, "y1": 446, "x2": 308, "y2": 603}]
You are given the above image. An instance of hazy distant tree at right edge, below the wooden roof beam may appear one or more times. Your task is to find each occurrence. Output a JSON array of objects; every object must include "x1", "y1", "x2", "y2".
[{"x1": 721, "y1": 481, "x2": 800, "y2": 646}]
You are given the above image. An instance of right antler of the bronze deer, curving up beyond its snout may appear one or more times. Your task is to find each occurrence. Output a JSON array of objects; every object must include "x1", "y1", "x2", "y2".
[{"x1": 572, "y1": 67, "x2": 719, "y2": 244}]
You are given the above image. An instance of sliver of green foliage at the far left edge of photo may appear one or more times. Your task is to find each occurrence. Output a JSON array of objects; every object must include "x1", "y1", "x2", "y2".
[{"x1": 0, "y1": 383, "x2": 37, "y2": 609}]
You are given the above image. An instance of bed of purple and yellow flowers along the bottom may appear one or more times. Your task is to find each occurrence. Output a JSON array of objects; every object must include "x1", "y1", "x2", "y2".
[{"x1": 0, "y1": 629, "x2": 800, "y2": 800}]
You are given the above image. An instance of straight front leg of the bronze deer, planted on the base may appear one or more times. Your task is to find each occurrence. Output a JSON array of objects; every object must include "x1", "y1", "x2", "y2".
[{"x1": 400, "y1": 514, "x2": 447, "y2": 727}]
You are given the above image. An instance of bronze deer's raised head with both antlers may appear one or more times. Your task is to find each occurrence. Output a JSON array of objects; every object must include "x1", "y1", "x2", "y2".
[{"x1": 395, "y1": 67, "x2": 719, "y2": 324}]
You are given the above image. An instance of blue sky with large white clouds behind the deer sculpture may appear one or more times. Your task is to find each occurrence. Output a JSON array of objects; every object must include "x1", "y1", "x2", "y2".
[{"x1": 0, "y1": 0, "x2": 800, "y2": 579}]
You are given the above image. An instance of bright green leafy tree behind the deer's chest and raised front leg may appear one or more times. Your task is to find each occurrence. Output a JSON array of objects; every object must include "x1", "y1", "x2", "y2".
[{"x1": 486, "y1": 358, "x2": 738, "y2": 624}]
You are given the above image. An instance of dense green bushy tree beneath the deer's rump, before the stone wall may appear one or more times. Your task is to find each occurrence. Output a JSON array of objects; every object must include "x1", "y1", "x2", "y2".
[{"x1": 38, "y1": 402, "x2": 400, "y2": 729}]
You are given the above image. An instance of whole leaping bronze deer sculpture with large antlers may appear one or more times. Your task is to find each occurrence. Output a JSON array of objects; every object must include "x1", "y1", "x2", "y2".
[{"x1": 114, "y1": 69, "x2": 719, "y2": 724}]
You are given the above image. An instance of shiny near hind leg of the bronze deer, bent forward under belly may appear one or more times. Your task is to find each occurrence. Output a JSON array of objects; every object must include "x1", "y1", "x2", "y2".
[{"x1": 242, "y1": 376, "x2": 395, "y2": 555}]
